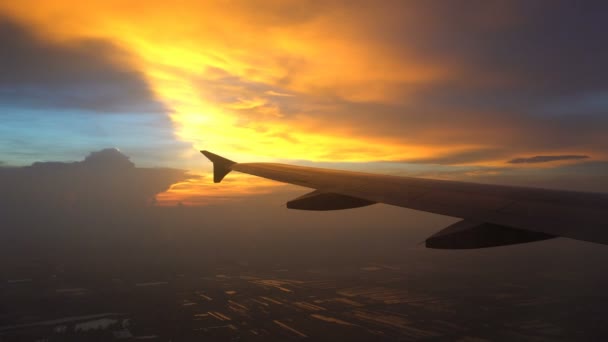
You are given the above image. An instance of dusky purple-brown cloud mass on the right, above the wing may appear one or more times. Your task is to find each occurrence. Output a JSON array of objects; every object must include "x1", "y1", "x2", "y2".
[{"x1": 296, "y1": 1, "x2": 608, "y2": 163}]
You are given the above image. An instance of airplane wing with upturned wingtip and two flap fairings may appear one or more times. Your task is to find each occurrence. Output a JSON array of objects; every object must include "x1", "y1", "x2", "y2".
[{"x1": 201, "y1": 151, "x2": 608, "y2": 249}]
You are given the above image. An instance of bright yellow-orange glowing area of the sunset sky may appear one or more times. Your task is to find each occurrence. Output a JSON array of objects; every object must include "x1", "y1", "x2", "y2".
[{"x1": 3, "y1": 1, "x2": 560, "y2": 161}]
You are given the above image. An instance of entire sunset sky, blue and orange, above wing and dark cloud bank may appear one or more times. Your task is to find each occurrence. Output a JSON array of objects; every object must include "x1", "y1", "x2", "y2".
[{"x1": 0, "y1": 0, "x2": 608, "y2": 204}]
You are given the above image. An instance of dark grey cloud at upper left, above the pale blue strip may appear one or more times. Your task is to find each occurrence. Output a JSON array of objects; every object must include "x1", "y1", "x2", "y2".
[{"x1": 0, "y1": 18, "x2": 164, "y2": 112}]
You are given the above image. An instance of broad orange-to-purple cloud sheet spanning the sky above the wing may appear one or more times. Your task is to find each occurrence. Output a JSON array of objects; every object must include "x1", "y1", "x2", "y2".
[{"x1": 4, "y1": 1, "x2": 608, "y2": 165}]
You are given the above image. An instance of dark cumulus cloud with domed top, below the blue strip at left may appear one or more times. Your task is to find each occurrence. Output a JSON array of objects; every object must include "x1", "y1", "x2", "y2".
[{"x1": 0, "y1": 149, "x2": 185, "y2": 217}]
